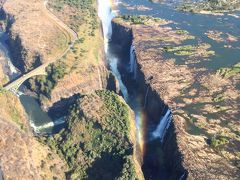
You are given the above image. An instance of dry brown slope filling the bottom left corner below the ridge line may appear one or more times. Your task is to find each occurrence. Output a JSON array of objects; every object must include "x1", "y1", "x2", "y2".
[{"x1": 0, "y1": 118, "x2": 66, "y2": 180}]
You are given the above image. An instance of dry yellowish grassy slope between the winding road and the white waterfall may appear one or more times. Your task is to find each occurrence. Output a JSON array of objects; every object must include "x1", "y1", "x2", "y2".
[{"x1": 37, "y1": 0, "x2": 108, "y2": 109}]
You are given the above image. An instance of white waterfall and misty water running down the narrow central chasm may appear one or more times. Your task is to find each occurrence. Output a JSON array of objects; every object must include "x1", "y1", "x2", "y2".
[{"x1": 98, "y1": 0, "x2": 172, "y2": 179}]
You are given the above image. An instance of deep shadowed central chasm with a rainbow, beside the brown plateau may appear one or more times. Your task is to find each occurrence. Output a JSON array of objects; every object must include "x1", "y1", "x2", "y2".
[{"x1": 97, "y1": 0, "x2": 187, "y2": 179}]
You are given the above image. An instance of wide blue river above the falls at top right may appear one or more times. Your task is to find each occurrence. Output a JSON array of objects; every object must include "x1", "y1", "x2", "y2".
[{"x1": 118, "y1": 0, "x2": 240, "y2": 71}]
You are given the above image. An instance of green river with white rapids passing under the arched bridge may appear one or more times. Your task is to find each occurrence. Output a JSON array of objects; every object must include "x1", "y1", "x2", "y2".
[{"x1": 0, "y1": 29, "x2": 65, "y2": 134}]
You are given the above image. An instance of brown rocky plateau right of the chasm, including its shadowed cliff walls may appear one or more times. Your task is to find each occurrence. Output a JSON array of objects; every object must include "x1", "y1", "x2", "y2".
[{"x1": 113, "y1": 17, "x2": 239, "y2": 179}]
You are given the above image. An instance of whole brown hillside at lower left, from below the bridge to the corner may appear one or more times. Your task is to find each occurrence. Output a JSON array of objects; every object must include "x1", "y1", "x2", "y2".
[{"x1": 0, "y1": 92, "x2": 66, "y2": 179}]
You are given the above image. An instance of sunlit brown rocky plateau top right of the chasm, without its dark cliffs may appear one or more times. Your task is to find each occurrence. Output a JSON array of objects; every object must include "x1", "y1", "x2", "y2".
[{"x1": 115, "y1": 16, "x2": 240, "y2": 179}]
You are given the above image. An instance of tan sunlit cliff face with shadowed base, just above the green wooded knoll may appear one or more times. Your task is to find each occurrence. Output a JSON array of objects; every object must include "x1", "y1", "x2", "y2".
[{"x1": 42, "y1": 64, "x2": 113, "y2": 111}]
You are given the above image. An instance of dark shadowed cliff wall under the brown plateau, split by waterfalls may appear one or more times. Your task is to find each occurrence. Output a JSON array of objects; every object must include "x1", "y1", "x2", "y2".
[{"x1": 112, "y1": 19, "x2": 192, "y2": 179}]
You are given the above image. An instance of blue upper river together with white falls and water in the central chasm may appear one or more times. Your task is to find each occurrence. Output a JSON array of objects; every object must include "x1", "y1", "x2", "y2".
[{"x1": 98, "y1": 0, "x2": 240, "y2": 180}]
